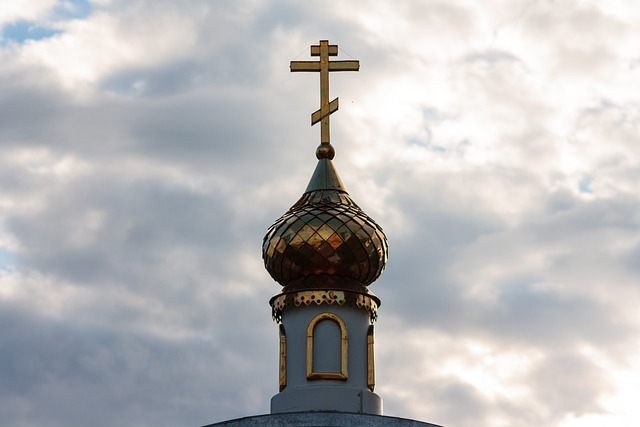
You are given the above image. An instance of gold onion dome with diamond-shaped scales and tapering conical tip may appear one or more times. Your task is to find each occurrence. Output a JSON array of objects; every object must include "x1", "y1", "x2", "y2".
[{"x1": 262, "y1": 144, "x2": 388, "y2": 298}]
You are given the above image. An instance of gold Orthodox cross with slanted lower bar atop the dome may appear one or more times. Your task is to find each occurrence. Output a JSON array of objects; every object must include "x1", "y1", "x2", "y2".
[{"x1": 291, "y1": 40, "x2": 360, "y2": 159}]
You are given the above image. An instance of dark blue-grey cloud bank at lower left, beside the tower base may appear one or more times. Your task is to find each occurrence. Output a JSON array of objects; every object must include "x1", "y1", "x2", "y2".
[{"x1": 0, "y1": 304, "x2": 273, "y2": 426}]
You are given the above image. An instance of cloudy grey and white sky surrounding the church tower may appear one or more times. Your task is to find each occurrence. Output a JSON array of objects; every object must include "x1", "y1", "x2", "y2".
[{"x1": 0, "y1": 0, "x2": 640, "y2": 427}]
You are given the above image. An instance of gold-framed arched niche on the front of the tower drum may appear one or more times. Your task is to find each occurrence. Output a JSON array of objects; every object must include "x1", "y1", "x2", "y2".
[{"x1": 307, "y1": 313, "x2": 349, "y2": 381}]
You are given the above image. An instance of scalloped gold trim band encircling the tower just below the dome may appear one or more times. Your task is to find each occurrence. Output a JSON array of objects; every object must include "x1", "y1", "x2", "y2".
[{"x1": 269, "y1": 290, "x2": 379, "y2": 323}]
